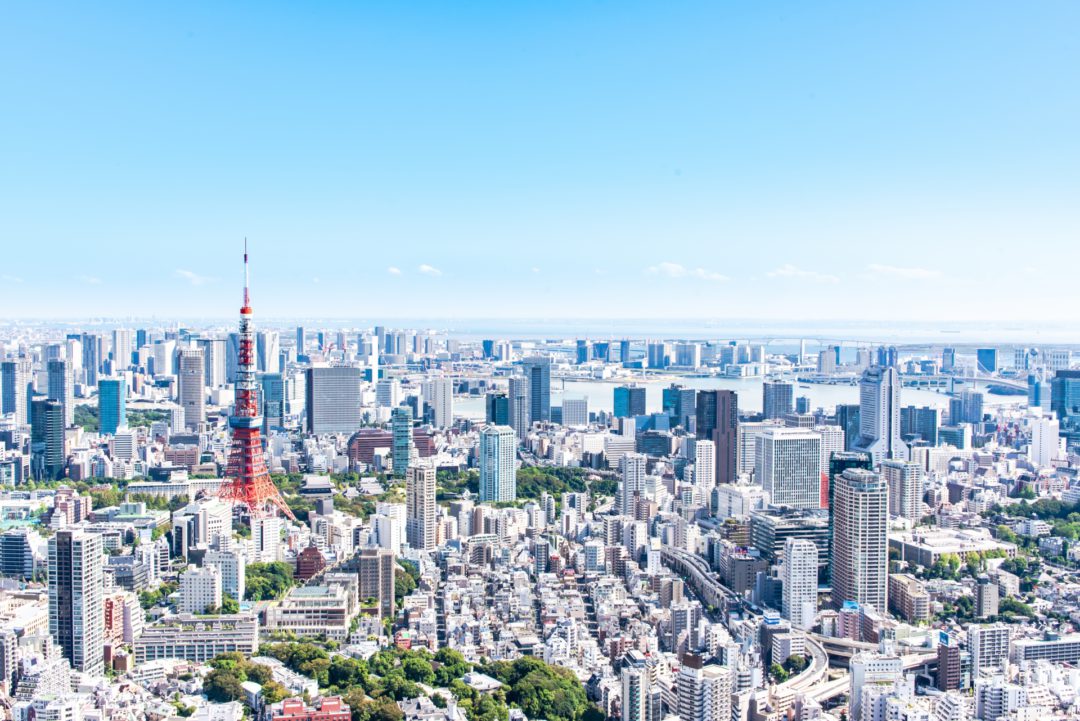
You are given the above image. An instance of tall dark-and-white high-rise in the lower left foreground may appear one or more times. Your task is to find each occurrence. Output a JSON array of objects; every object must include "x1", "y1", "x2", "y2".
[{"x1": 49, "y1": 531, "x2": 105, "y2": 676}]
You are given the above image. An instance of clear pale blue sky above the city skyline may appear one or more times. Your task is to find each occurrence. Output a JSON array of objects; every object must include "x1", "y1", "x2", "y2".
[{"x1": 0, "y1": 0, "x2": 1080, "y2": 321}]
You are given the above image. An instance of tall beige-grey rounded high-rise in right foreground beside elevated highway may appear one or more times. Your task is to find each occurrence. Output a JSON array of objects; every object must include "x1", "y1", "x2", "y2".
[{"x1": 831, "y1": 468, "x2": 889, "y2": 613}]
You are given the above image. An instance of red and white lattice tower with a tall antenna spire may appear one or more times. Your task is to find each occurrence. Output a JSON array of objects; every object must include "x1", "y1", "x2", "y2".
[{"x1": 218, "y1": 241, "x2": 296, "y2": 520}]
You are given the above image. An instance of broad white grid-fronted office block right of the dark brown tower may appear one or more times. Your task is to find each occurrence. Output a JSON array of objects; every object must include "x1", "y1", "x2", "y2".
[{"x1": 754, "y1": 427, "x2": 821, "y2": 508}]
